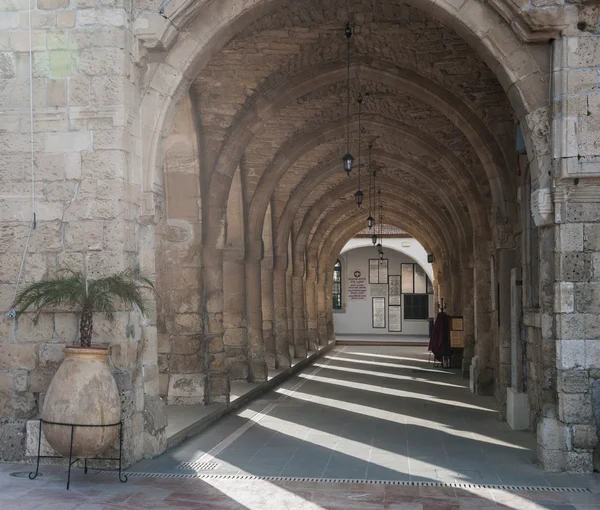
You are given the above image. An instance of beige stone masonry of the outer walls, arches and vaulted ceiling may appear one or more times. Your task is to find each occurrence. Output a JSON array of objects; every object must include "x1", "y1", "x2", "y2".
[{"x1": 0, "y1": 0, "x2": 600, "y2": 471}]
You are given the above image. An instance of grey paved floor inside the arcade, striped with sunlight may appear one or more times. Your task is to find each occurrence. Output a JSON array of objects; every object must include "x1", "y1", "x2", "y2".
[{"x1": 131, "y1": 346, "x2": 587, "y2": 486}]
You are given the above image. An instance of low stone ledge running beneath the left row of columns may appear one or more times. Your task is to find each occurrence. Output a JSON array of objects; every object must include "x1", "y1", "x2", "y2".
[{"x1": 166, "y1": 341, "x2": 336, "y2": 450}]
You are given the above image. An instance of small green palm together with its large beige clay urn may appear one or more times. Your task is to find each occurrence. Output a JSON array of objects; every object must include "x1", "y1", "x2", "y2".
[{"x1": 14, "y1": 267, "x2": 154, "y2": 458}]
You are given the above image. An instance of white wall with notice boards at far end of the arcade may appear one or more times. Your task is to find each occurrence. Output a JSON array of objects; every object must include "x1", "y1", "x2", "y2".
[{"x1": 334, "y1": 238, "x2": 435, "y2": 340}]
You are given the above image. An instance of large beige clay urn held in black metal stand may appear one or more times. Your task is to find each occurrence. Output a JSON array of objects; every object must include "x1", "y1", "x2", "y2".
[{"x1": 42, "y1": 346, "x2": 121, "y2": 458}]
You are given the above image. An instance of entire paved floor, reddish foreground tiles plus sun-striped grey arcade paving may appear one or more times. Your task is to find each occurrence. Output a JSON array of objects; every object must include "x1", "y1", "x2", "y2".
[{"x1": 0, "y1": 346, "x2": 600, "y2": 510}]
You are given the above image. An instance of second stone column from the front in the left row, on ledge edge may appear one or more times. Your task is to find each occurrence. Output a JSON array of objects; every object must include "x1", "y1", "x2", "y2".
[{"x1": 246, "y1": 241, "x2": 268, "y2": 382}]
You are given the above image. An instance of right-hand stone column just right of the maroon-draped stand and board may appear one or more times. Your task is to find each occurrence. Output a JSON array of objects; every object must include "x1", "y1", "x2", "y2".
[{"x1": 471, "y1": 238, "x2": 494, "y2": 395}]
